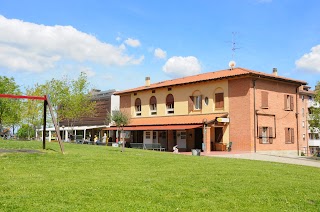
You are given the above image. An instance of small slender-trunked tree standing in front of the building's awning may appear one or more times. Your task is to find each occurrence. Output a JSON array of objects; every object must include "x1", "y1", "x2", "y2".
[{"x1": 106, "y1": 110, "x2": 130, "y2": 152}]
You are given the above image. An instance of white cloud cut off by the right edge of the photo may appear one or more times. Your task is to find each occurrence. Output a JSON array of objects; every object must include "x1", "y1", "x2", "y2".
[{"x1": 296, "y1": 45, "x2": 320, "y2": 72}]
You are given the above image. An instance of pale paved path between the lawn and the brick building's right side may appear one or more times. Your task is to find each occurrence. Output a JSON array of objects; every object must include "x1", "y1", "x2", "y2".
[{"x1": 207, "y1": 153, "x2": 320, "y2": 168}]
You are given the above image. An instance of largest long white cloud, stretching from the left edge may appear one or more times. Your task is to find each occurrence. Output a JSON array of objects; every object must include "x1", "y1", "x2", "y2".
[{"x1": 0, "y1": 15, "x2": 141, "y2": 72}]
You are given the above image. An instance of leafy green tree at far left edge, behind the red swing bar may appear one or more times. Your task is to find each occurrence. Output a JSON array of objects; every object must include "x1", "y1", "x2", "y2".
[{"x1": 0, "y1": 76, "x2": 21, "y2": 131}]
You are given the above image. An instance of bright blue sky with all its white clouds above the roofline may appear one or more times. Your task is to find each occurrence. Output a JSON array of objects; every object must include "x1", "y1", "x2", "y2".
[{"x1": 0, "y1": 0, "x2": 320, "y2": 90}]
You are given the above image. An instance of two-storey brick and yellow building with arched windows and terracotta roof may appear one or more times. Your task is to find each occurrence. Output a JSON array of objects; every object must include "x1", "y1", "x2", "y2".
[{"x1": 111, "y1": 68, "x2": 307, "y2": 154}]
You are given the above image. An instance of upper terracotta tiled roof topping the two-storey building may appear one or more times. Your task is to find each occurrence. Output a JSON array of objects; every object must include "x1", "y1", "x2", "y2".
[{"x1": 114, "y1": 67, "x2": 307, "y2": 95}]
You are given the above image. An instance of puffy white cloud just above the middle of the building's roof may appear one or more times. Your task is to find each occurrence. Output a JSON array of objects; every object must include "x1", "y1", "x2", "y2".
[{"x1": 162, "y1": 56, "x2": 201, "y2": 77}]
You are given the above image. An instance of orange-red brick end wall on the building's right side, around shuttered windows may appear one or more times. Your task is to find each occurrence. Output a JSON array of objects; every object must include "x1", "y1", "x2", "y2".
[{"x1": 251, "y1": 79, "x2": 298, "y2": 151}]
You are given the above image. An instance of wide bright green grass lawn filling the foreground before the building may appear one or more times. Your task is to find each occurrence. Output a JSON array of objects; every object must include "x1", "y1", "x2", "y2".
[{"x1": 0, "y1": 140, "x2": 320, "y2": 211}]
